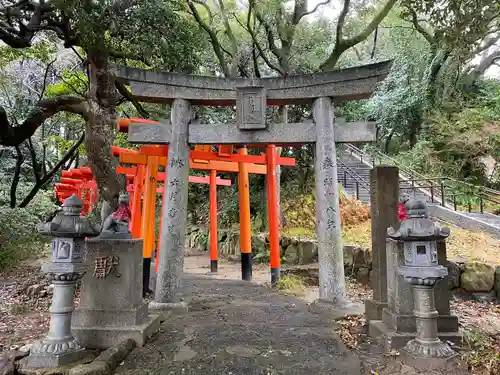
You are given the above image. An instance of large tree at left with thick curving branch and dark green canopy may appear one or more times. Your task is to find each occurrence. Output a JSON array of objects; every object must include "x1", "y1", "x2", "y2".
[{"x1": 0, "y1": 0, "x2": 201, "y2": 205}]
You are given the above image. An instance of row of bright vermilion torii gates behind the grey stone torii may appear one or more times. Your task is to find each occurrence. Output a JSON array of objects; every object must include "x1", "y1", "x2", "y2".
[{"x1": 55, "y1": 118, "x2": 295, "y2": 295}]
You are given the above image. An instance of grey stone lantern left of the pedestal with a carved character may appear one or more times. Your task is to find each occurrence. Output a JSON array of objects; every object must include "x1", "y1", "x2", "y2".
[{"x1": 25, "y1": 194, "x2": 98, "y2": 368}]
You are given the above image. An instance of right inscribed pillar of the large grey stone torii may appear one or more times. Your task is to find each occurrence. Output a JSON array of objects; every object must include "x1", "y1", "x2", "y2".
[{"x1": 313, "y1": 97, "x2": 347, "y2": 307}]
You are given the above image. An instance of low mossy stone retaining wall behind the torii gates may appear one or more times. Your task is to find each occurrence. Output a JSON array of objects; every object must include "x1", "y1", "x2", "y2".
[{"x1": 187, "y1": 228, "x2": 500, "y2": 300}]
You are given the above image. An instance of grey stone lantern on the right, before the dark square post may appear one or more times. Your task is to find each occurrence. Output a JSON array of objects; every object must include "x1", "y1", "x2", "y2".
[{"x1": 387, "y1": 198, "x2": 456, "y2": 368}]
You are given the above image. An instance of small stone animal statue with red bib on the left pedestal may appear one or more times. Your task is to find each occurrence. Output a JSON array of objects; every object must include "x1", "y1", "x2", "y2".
[{"x1": 98, "y1": 193, "x2": 132, "y2": 239}]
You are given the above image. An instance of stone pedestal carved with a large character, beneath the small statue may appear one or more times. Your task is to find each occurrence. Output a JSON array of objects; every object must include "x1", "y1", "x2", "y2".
[{"x1": 71, "y1": 238, "x2": 160, "y2": 349}]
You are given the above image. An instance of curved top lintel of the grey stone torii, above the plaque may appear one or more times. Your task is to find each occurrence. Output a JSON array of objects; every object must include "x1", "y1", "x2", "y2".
[{"x1": 116, "y1": 61, "x2": 392, "y2": 105}]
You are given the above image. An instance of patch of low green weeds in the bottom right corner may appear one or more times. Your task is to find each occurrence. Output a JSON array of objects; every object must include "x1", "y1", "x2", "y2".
[{"x1": 463, "y1": 329, "x2": 500, "y2": 375}]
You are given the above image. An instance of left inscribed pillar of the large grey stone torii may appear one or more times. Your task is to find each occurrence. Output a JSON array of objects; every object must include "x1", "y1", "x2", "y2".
[{"x1": 150, "y1": 99, "x2": 191, "y2": 310}]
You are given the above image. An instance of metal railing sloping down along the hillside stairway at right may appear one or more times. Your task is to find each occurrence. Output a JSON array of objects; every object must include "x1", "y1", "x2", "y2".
[{"x1": 345, "y1": 144, "x2": 500, "y2": 213}]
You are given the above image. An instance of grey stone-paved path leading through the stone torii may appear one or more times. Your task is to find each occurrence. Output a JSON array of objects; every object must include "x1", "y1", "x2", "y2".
[{"x1": 117, "y1": 256, "x2": 361, "y2": 375}]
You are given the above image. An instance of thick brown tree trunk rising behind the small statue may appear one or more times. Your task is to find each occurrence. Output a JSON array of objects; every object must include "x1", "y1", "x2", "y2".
[{"x1": 85, "y1": 51, "x2": 123, "y2": 209}]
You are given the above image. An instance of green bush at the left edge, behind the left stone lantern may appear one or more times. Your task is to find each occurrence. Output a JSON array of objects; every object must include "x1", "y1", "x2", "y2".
[{"x1": 0, "y1": 185, "x2": 56, "y2": 270}]
